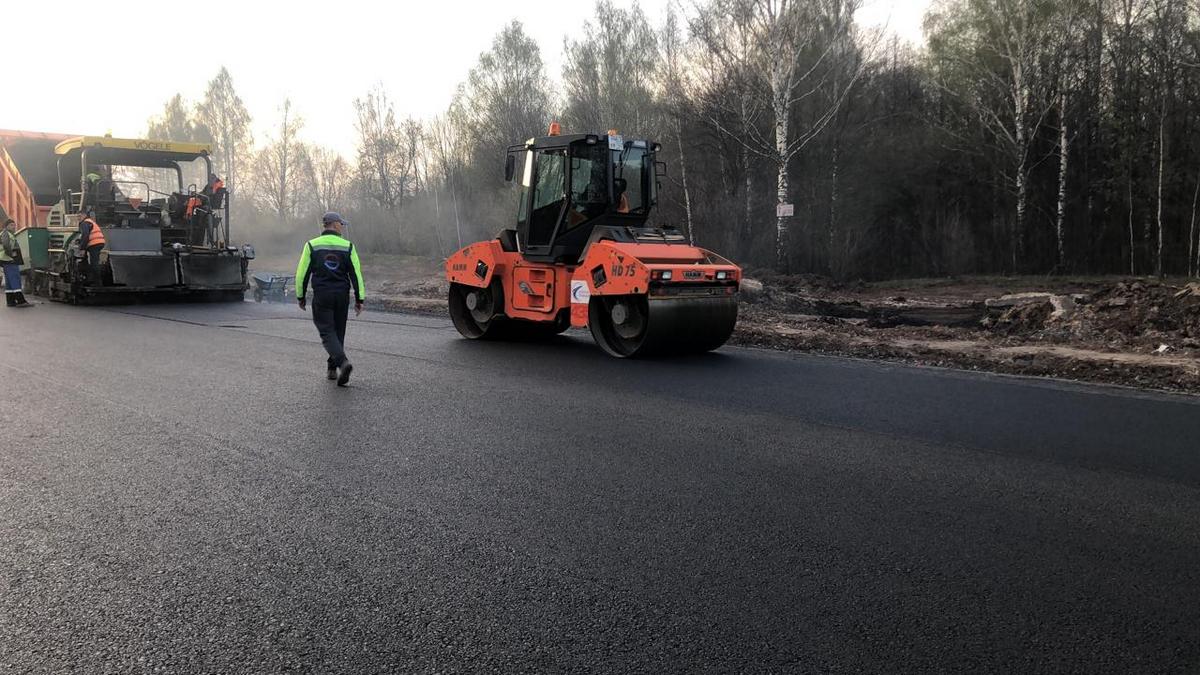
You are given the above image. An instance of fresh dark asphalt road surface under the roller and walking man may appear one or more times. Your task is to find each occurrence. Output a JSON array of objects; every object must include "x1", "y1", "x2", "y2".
[{"x1": 0, "y1": 303, "x2": 1200, "y2": 674}]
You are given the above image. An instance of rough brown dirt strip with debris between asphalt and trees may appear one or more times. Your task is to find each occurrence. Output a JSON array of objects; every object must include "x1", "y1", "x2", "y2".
[{"x1": 254, "y1": 249, "x2": 1200, "y2": 393}]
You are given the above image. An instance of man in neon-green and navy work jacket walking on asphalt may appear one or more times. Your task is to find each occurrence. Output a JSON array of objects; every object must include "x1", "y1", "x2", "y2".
[{"x1": 296, "y1": 211, "x2": 366, "y2": 387}]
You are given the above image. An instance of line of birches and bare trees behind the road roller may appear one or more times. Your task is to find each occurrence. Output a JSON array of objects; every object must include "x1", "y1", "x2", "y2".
[{"x1": 148, "y1": 0, "x2": 1200, "y2": 279}]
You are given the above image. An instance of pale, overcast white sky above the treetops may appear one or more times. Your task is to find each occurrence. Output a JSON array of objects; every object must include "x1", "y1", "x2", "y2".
[{"x1": 0, "y1": 0, "x2": 929, "y2": 156}]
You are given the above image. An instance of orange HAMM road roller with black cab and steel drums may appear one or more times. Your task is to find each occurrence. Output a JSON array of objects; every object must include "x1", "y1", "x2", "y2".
[{"x1": 445, "y1": 124, "x2": 742, "y2": 358}]
